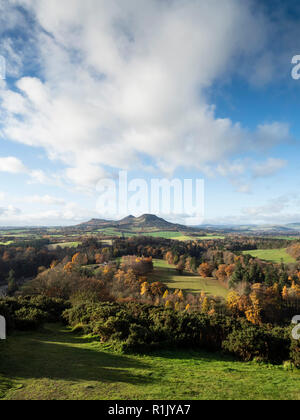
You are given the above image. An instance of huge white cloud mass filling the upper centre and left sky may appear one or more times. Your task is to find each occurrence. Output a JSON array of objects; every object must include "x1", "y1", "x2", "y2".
[{"x1": 0, "y1": 0, "x2": 289, "y2": 187}]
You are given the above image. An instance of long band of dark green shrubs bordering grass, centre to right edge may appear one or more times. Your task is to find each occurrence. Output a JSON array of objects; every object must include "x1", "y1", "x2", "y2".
[{"x1": 64, "y1": 303, "x2": 299, "y2": 364}]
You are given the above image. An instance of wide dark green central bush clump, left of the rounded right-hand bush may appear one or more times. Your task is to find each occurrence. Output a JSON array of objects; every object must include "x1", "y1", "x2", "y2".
[{"x1": 64, "y1": 303, "x2": 237, "y2": 351}]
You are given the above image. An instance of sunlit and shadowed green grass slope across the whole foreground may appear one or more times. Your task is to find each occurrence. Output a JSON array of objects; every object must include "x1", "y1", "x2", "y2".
[{"x1": 0, "y1": 325, "x2": 300, "y2": 400}]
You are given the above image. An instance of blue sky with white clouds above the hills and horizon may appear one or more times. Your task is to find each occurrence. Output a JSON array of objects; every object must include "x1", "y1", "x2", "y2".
[{"x1": 0, "y1": 0, "x2": 300, "y2": 226}]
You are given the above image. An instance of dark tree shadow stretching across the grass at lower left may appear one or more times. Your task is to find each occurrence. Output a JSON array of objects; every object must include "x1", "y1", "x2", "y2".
[{"x1": 0, "y1": 327, "x2": 153, "y2": 384}]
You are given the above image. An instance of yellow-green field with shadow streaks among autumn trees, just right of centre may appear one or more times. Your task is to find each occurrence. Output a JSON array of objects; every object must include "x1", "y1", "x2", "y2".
[{"x1": 150, "y1": 260, "x2": 228, "y2": 298}]
